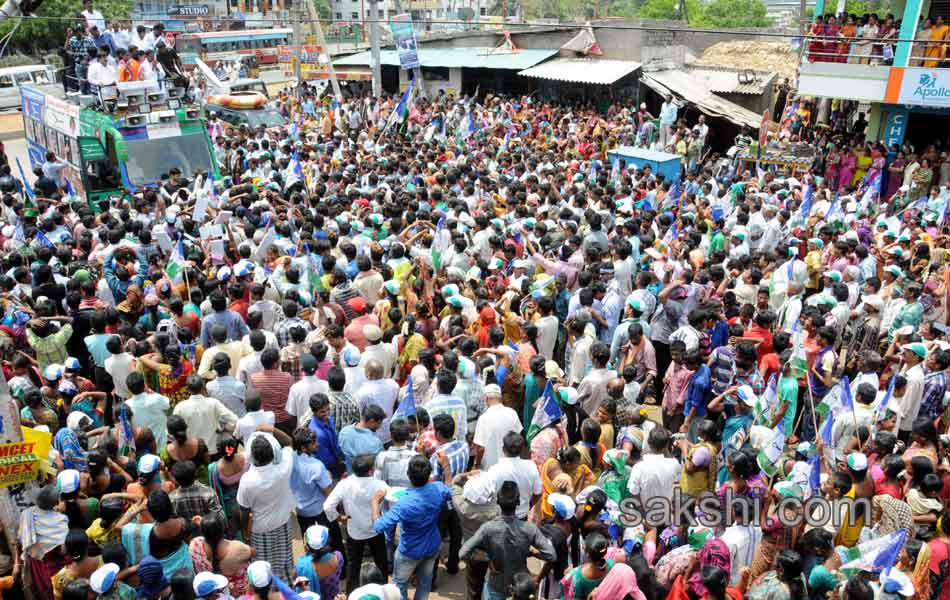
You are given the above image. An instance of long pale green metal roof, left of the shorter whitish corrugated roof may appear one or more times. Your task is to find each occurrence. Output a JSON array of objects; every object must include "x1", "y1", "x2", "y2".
[{"x1": 333, "y1": 47, "x2": 558, "y2": 71}]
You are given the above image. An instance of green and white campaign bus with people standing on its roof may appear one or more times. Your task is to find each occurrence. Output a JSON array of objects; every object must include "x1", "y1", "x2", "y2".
[{"x1": 21, "y1": 81, "x2": 220, "y2": 209}]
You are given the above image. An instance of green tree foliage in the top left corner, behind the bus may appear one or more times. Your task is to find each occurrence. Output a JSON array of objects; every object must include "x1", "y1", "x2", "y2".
[{"x1": 0, "y1": 0, "x2": 132, "y2": 52}]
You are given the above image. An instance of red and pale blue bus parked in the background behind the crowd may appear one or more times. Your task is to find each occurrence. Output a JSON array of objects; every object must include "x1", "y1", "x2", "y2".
[{"x1": 175, "y1": 28, "x2": 293, "y2": 67}]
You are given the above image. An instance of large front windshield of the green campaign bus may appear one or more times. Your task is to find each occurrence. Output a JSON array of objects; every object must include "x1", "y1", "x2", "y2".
[{"x1": 125, "y1": 133, "x2": 211, "y2": 186}]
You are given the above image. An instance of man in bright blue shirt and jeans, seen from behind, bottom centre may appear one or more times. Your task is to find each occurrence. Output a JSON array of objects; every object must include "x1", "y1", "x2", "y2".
[{"x1": 373, "y1": 455, "x2": 454, "y2": 600}]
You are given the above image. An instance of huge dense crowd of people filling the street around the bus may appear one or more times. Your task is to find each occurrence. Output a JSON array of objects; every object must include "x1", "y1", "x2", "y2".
[{"x1": 0, "y1": 48, "x2": 950, "y2": 600}]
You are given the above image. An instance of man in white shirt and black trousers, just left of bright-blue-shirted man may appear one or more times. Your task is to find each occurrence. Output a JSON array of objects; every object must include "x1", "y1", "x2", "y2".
[{"x1": 323, "y1": 454, "x2": 389, "y2": 592}]
